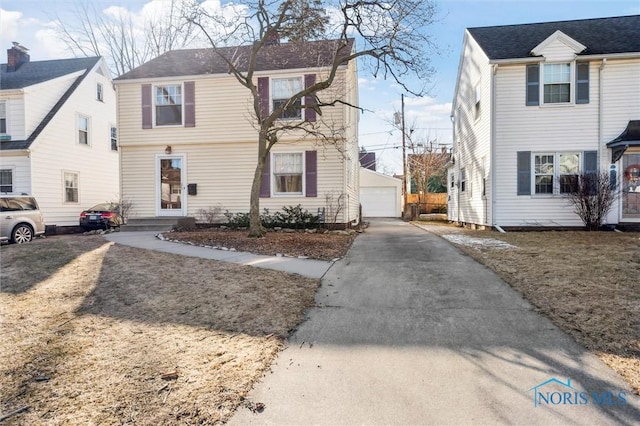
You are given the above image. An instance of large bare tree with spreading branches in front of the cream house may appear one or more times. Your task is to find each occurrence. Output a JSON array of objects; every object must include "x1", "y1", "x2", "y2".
[{"x1": 189, "y1": 0, "x2": 436, "y2": 237}]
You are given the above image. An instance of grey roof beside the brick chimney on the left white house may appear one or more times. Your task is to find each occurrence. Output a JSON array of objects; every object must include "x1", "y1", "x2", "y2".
[{"x1": 0, "y1": 57, "x2": 100, "y2": 90}]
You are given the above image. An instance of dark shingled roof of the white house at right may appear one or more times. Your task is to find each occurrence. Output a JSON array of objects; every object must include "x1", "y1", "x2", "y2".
[{"x1": 468, "y1": 15, "x2": 640, "y2": 60}]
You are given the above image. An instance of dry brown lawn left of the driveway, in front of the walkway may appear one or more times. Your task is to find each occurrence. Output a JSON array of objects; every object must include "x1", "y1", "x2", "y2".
[{"x1": 0, "y1": 236, "x2": 319, "y2": 425}]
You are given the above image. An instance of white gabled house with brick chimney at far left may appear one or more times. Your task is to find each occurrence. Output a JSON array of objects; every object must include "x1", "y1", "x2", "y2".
[{"x1": 0, "y1": 43, "x2": 119, "y2": 226}]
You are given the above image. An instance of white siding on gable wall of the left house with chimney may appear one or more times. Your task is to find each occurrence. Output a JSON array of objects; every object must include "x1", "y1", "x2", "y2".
[{"x1": 27, "y1": 61, "x2": 119, "y2": 226}]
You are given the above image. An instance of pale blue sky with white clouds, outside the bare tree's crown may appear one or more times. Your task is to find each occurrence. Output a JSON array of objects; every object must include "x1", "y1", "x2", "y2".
[{"x1": 0, "y1": 0, "x2": 640, "y2": 173}]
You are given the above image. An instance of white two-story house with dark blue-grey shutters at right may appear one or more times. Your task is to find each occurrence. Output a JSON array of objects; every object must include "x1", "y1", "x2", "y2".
[{"x1": 447, "y1": 15, "x2": 640, "y2": 227}]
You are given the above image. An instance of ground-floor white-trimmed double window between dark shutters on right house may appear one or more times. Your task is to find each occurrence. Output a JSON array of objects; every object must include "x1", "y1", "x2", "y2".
[{"x1": 533, "y1": 152, "x2": 580, "y2": 194}]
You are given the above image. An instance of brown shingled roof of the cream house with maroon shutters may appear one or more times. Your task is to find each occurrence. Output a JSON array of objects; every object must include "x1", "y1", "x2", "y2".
[{"x1": 115, "y1": 39, "x2": 354, "y2": 81}]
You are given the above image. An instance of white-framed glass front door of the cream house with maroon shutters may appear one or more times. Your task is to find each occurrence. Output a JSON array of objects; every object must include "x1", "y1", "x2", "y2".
[{"x1": 156, "y1": 156, "x2": 186, "y2": 216}]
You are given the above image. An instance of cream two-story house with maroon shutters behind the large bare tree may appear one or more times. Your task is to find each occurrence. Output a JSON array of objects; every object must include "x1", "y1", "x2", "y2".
[{"x1": 114, "y1": 41, "x2": 360, "y2": 225}]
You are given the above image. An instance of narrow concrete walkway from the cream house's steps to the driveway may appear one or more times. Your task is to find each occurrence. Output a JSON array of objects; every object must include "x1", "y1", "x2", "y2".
[{"x1": 104, "y1": 231, "x2": 333, "y2": 278}]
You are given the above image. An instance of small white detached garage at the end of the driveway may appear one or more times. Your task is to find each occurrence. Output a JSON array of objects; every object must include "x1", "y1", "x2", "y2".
[{"x1": 360, "y1": 167, "x2": 402, "y2": 218}]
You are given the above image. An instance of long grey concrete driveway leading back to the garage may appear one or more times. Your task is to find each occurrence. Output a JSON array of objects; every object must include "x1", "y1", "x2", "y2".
[{"x1": 231, "y1": 220, "x2": 640, "y2": 425}]
